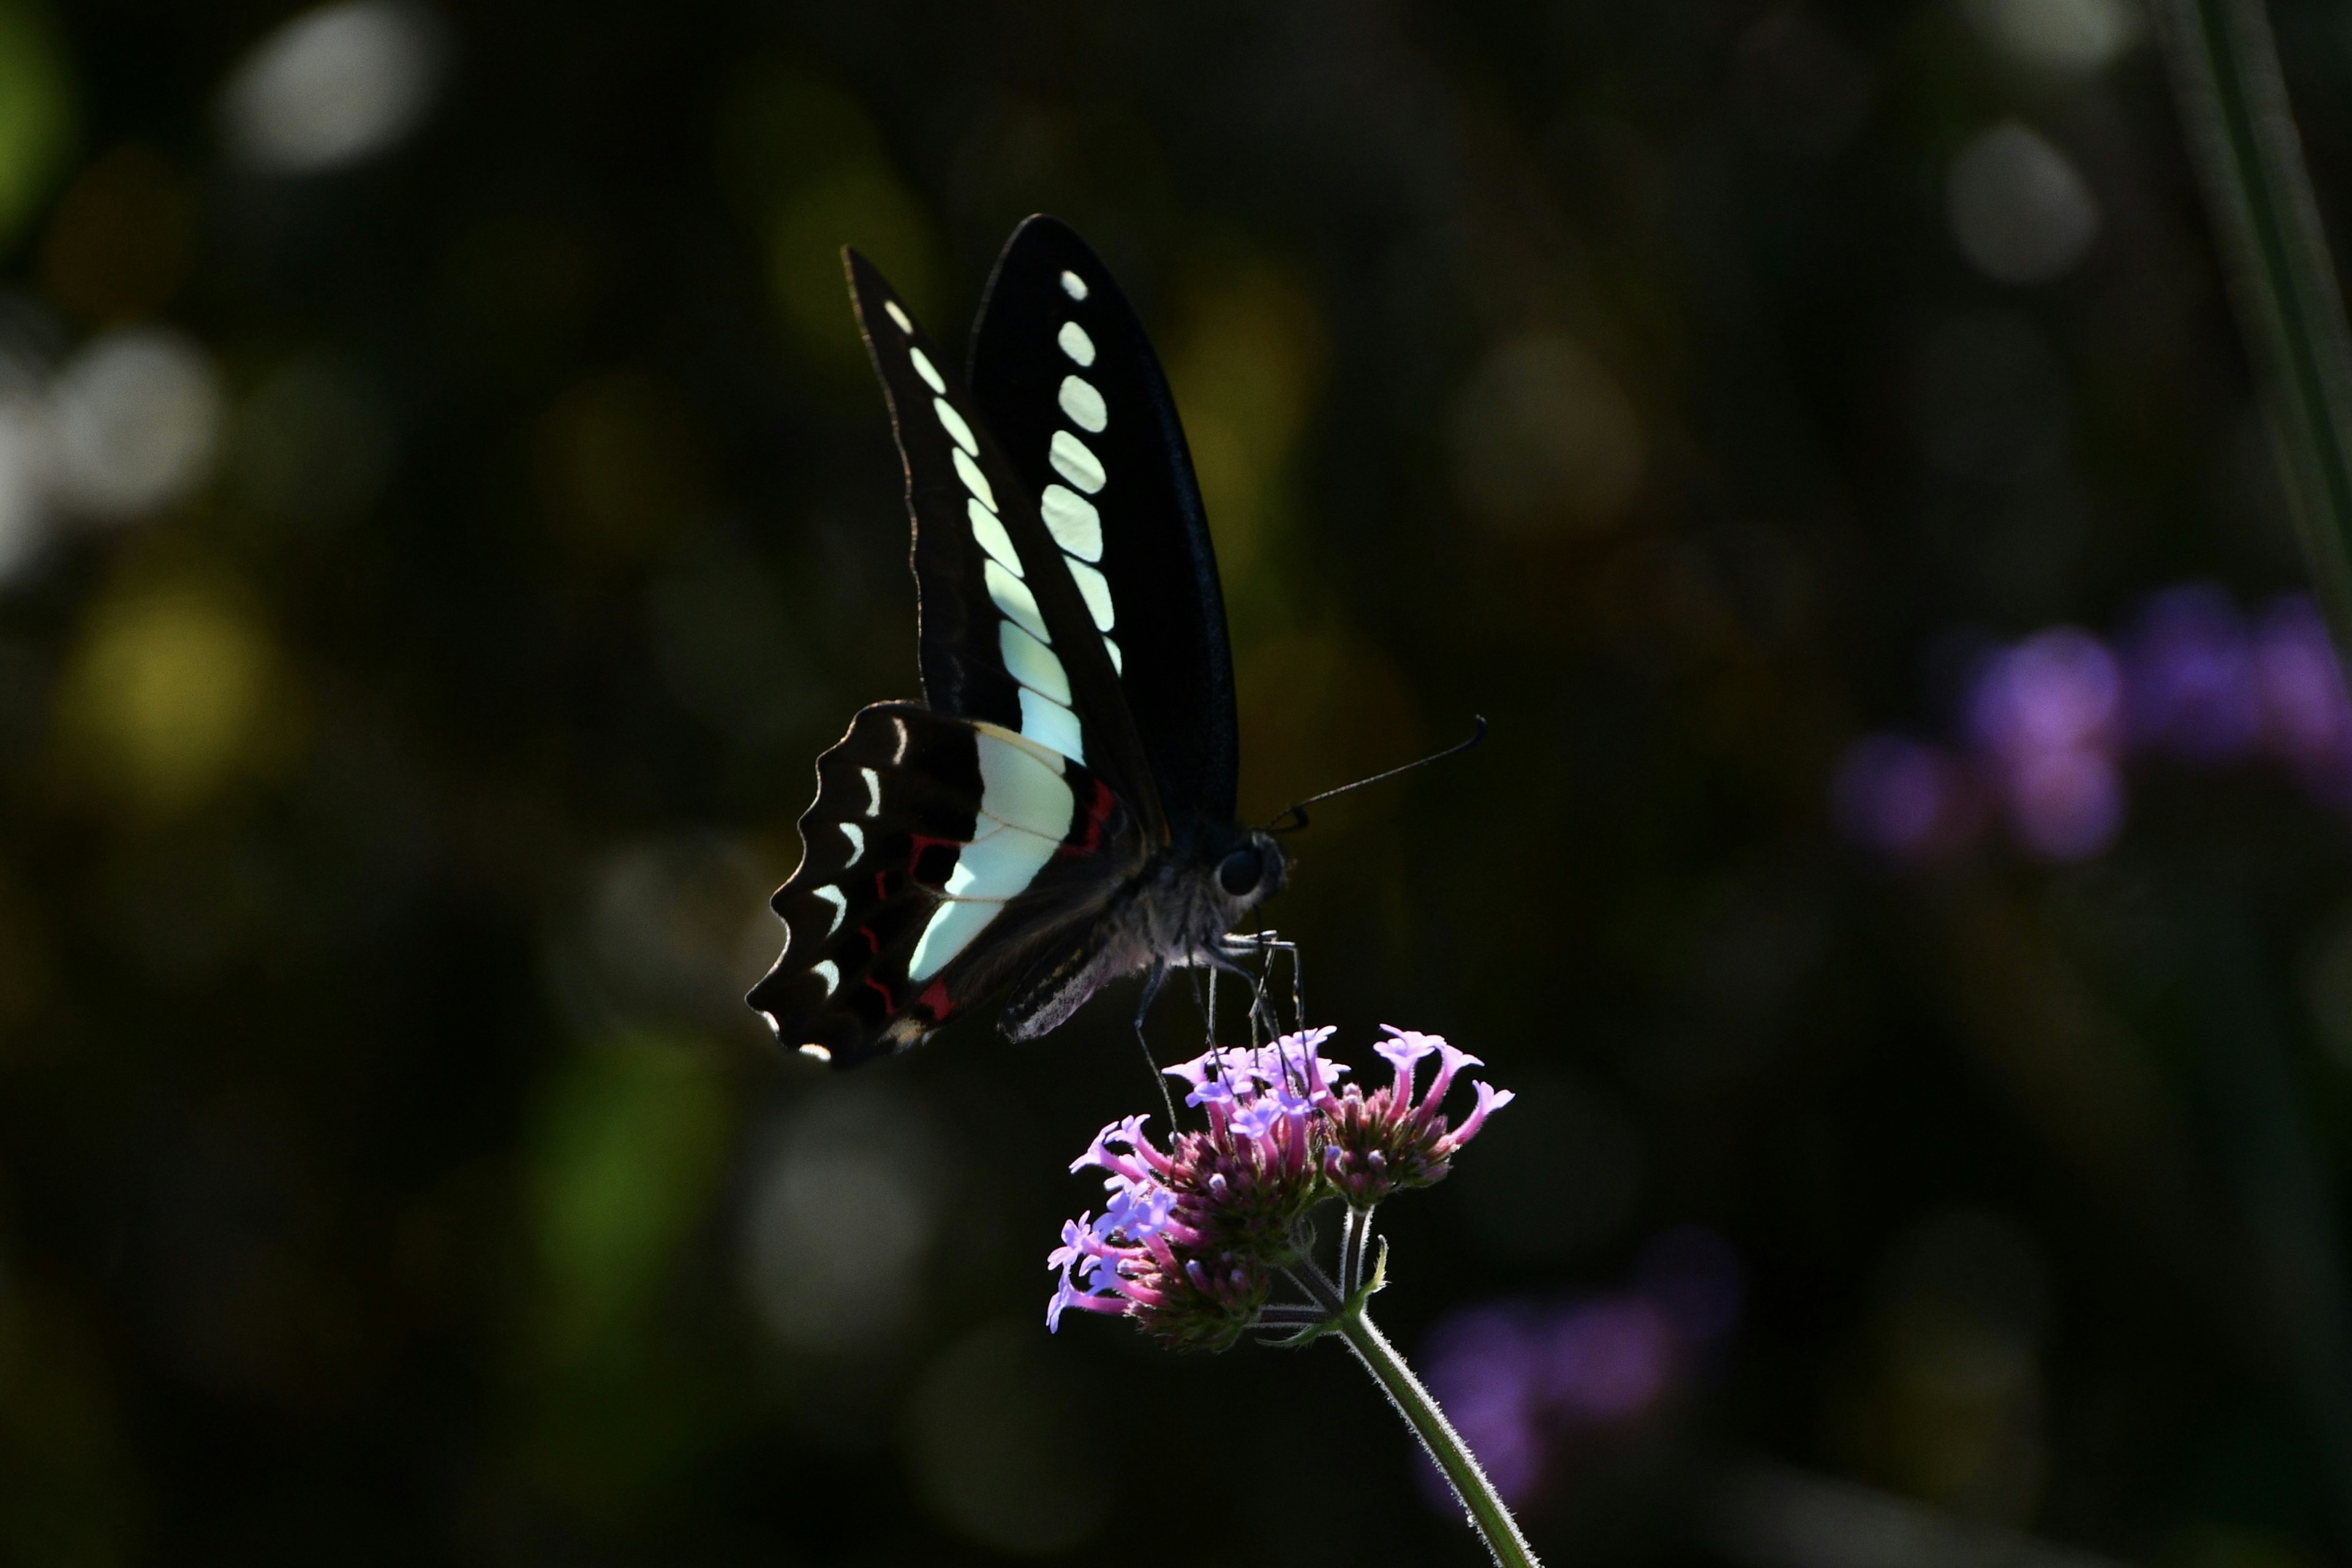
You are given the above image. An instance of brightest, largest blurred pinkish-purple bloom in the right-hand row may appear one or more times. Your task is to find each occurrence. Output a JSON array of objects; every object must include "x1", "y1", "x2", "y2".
[{"x1": 1969, "y1": 625, "x2": 2124, "y2": 861}]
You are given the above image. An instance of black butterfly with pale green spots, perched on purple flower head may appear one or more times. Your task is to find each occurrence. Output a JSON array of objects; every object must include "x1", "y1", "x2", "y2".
[{"x1": 750, "y1": 216, "x2": 1286, "y2": 1067}]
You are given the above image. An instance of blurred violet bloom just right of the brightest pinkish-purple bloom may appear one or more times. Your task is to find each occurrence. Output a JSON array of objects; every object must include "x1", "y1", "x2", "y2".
[{"x1": 2124, "y1": 583, "x2": 2260, "y2": 766}]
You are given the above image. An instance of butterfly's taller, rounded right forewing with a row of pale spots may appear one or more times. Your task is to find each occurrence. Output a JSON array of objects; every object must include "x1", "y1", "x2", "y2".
[{"x1": 971, "y1": 216, "x2": 1240, "y2": 823}]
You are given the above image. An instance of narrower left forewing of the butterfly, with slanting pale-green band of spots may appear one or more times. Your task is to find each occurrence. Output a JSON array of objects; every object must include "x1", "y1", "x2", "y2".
[{"x1": 846, "y1": 252, "x2": 1164, "y2": 837}]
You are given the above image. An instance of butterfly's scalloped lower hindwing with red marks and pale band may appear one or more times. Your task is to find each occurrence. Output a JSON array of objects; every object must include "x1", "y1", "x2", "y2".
[{"x1": 750, "y1": 703, "x2": 1148, "y2": 1067}]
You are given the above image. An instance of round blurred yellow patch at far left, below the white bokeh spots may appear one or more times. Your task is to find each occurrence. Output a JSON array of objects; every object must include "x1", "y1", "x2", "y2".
[{"x1": 56, "y1": 576, "x2": 292, "y2": 816}]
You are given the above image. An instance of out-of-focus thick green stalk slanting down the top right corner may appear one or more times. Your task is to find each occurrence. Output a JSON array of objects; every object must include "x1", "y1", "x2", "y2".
[{"x1": 2152, "y1": 0, "x2": 2352, "y2": 651}]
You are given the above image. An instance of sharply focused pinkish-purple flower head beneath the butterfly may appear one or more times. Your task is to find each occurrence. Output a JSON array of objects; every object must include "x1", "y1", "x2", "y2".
[{"x1": 1047, "y1": 1027, "x2": 1510, "y2": 1349}]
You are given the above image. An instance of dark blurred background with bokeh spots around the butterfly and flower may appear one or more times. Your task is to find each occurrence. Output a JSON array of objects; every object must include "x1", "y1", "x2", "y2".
[{"x1": 0, "y1": 0, "x2": 2352, "y2": 1568}]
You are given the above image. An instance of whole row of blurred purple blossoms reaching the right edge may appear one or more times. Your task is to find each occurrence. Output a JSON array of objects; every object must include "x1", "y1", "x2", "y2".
[{"x1": 1832, "y1": 583, "x2": 2352, "y2": 865}]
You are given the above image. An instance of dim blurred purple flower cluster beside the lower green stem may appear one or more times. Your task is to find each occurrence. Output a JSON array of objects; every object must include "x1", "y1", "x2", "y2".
[{"x1": 1423, "y1": 1227, "x2": 1743, "y2": 1507}]
